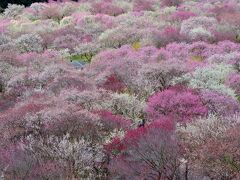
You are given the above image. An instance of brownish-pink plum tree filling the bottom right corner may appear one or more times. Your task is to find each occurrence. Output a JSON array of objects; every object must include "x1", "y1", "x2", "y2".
[{"x1": 195, "y1": 125, "x2": 240, "y2": 179}]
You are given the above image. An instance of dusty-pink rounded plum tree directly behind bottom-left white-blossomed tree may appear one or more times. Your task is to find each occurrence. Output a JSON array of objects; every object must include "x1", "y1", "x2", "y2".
[{"x1": 42, "y1": 106, "x2": 103, "y2": 141}]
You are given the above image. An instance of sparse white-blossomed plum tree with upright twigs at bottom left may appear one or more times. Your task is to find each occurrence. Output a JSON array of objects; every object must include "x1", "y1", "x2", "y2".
[{"x1": 25, "y1": 134, "x2": 104, "y2": 178}]
